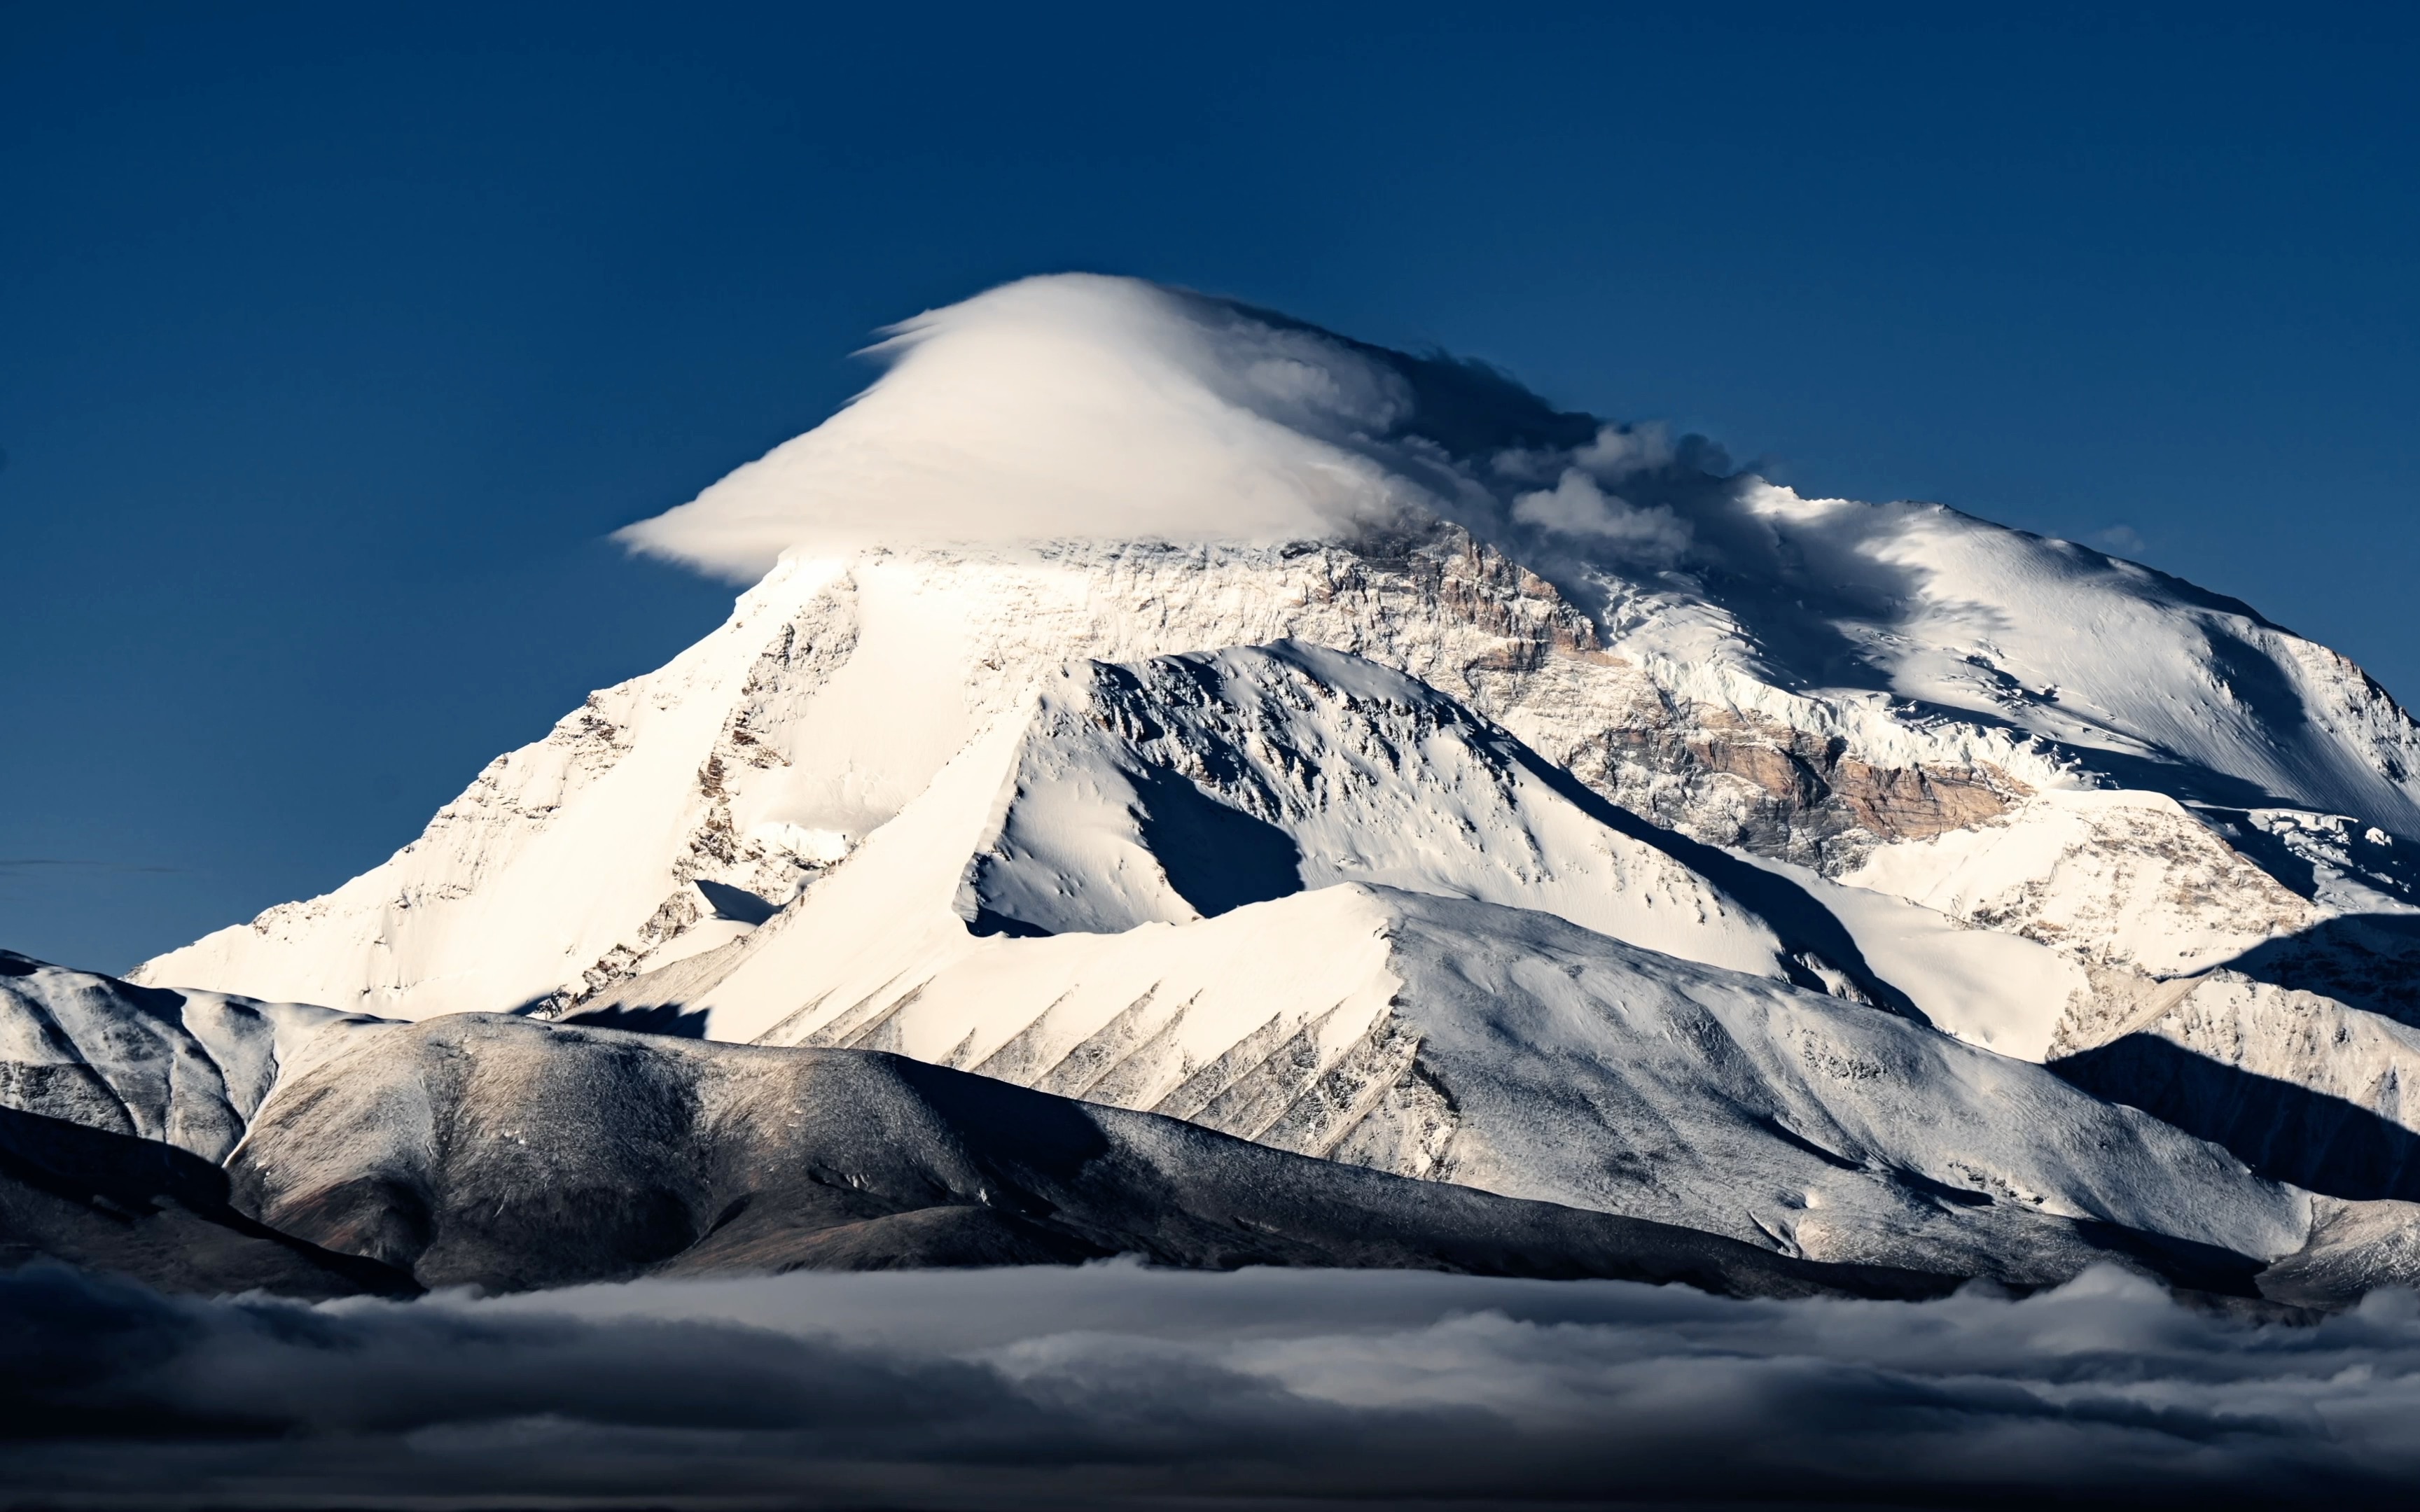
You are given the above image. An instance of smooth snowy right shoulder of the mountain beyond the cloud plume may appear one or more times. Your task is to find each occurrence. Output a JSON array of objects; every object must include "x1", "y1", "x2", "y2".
[{"x1": 1609, "y1": 484, "x2": 2420, "y2": 834}]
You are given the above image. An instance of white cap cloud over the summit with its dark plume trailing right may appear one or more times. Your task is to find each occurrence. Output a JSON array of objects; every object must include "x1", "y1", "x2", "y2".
[{"x1": 620, "y1": 276, "x2": 1716, "y2": 580}]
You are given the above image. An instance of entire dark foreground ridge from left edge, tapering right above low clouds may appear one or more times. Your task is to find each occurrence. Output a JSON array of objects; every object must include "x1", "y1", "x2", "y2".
[{"x1": 0, "y1": 953, "x2": 1955, "y2": 1296}]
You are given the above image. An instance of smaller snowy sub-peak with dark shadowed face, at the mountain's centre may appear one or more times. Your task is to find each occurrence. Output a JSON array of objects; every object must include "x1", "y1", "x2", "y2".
[{"x1": 959, "y1": 641, "x2": 1786, "y2": 975}]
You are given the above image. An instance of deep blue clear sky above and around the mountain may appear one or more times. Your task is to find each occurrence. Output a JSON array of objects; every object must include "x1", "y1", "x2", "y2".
[{"x1": 0, "y1": 0, "x2": 2420, "y2": 967}]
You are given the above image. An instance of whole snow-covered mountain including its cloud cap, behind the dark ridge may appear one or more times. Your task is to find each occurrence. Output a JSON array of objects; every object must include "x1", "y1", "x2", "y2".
[{"x1": 61, "y1": 278, "x2": 2420, "y2": 1278}]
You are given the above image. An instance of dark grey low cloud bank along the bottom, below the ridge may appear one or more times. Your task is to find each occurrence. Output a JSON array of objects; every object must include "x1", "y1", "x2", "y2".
[{"x1": 0, "y1": 1265, "x2": 2420, "y2": 1507}]
